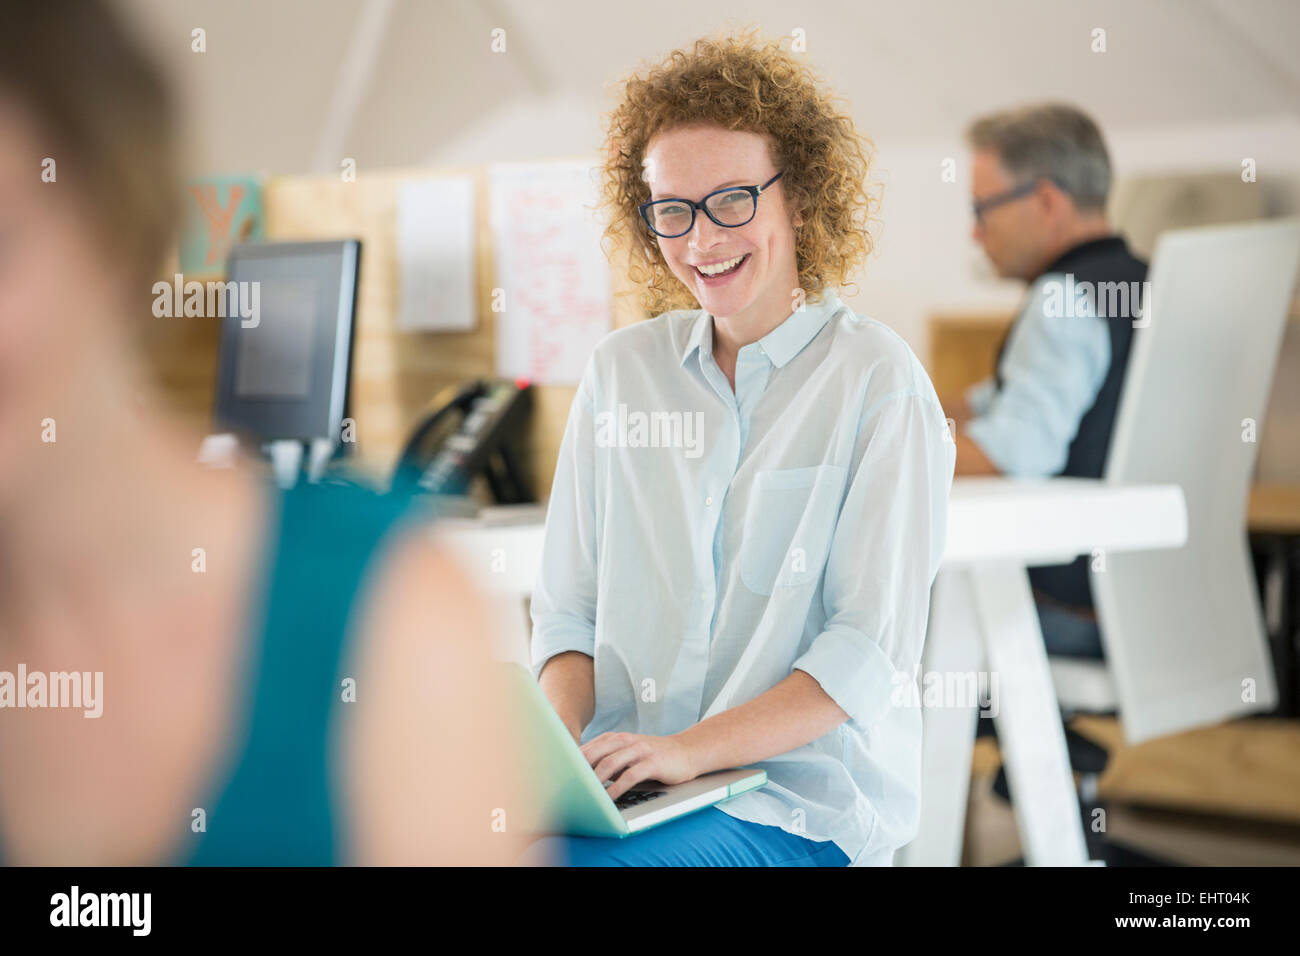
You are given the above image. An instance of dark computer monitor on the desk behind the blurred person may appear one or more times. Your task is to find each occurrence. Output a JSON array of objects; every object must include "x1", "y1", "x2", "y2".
[{"x1": 213, "y1": 239, "x2": 361, "y2": 444}]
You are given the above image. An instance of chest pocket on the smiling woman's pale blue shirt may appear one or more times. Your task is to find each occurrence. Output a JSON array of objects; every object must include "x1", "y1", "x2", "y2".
[{"x1": 740, "y1": 464, "x2": 849, "y2": 594}]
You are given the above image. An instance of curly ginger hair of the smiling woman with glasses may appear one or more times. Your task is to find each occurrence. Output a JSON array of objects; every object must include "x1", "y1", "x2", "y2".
[{"x1": 601, "y1": 29, "x2": 879, "y2": 315}]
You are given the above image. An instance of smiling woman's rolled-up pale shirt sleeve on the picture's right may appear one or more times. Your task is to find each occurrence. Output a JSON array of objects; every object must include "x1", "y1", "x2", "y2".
[{"x1": 794, "y1": 371, "x2": 956, "y2": 727}]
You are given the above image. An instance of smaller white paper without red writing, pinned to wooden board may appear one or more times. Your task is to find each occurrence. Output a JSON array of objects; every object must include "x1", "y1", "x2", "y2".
[{"x1": 397, "y1": 176, "x2": 476, "y2": 332}]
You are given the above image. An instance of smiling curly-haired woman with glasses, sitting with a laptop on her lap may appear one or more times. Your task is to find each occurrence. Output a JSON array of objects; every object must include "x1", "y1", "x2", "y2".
[{"x1": 532, "y1": 29, "x2": 954, "y2": 866}]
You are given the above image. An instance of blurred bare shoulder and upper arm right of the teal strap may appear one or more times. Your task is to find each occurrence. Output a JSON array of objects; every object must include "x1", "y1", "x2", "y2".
[{"x1": 341, "y1": 522, "x2": 533, "y2": 865}]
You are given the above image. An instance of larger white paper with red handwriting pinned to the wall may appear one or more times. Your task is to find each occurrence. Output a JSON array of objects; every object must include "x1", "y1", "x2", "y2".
[{"x1": 489, "y1": 163, "x2": 611, "y2": 385}]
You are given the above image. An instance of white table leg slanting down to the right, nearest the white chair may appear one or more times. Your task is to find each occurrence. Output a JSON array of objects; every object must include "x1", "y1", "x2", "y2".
[{"x1": 970, "y1": 562, "x2": 1088, "y2": 866}]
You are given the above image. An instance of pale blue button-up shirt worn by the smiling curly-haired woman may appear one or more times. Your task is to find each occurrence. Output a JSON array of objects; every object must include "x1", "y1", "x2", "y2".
[{"x1": 532, "y1": 290, "x2": 956, "y2": 865}]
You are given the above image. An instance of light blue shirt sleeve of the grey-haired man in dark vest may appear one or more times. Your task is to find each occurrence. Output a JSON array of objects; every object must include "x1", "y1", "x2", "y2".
[{"x1": 966, "y1": 274, "x2": 1110, "y2": 477}]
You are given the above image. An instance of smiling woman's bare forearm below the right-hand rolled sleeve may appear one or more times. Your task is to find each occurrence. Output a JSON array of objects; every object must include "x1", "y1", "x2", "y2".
[{"x1": 676, "y1": 670, "x2": 849, "y2": 774}]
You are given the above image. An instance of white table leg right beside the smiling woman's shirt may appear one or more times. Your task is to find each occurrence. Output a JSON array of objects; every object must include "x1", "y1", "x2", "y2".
[{"x1": 896, "y1": 567, "x2": 984, "y2": 866}]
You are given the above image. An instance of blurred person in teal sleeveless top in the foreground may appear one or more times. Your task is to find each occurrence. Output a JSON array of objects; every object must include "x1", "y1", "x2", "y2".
[{"x1": 0, "y1": 0, "x2": 519, "y2": 865}]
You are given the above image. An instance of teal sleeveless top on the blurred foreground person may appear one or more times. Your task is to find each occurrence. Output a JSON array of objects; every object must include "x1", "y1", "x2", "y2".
[{"x1": 0, "y1": 484, "x2": 433, "y2": 866}]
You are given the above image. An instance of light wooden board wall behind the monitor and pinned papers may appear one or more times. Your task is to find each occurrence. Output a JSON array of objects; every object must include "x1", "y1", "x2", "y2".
[{"x1": 142, "y1": 168, "x2": 644, "y2": 499}]
